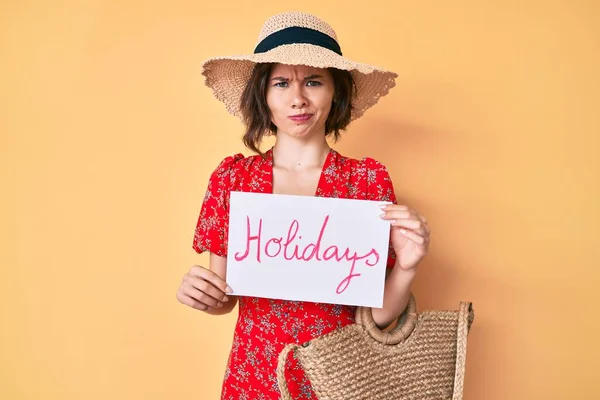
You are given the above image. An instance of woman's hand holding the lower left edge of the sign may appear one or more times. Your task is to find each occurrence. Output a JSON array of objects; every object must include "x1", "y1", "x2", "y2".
[{"x1": 177, "y1": 265, "x2": 232, "y2": 313}]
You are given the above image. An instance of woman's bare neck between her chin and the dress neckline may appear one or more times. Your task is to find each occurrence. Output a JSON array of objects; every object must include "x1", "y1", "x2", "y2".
[{"x1": 273, "y1": 135, "x2": 331, "y2": 170}]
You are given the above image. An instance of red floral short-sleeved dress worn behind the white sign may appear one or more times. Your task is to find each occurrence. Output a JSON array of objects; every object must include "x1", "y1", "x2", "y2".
[{"x1": 193, "y1": 149, "x2": 396, "y2": 400}]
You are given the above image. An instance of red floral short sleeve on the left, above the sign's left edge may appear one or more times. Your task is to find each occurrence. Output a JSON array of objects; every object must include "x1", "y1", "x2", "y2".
[{"x1": 192, "y1": 154, "x2": 243, "y2": 257}]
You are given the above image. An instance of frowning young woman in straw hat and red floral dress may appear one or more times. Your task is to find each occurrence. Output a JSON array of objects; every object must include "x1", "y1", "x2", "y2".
[{"x1": 177, "y1": 13, "x2": 430, "y2": 400}]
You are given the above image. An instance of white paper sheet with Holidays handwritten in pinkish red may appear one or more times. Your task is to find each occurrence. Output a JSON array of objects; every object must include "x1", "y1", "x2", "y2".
[{"x1": 226, "y1": 192, "x2": 390, "y2": 307}]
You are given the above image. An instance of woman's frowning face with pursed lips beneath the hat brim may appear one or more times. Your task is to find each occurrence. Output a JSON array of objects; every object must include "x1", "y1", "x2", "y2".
[{"x1": 267, "y1": 64, "x2": 334, "y2": 138}]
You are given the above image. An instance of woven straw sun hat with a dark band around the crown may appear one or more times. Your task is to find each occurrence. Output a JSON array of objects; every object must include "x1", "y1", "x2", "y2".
[{"x1": 202, "y1": 12, "x2": 398, "y2": 120}]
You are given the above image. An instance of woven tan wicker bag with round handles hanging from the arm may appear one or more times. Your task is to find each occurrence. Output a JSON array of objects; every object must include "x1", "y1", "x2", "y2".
[{"x1": 277, "y1": 295, "x2": 474, "y2": 400}]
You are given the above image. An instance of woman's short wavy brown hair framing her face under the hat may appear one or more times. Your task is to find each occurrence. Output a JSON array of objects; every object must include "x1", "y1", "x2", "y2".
[{"x1": 240, "y1": 63, "x2": 356, "y2": 155}]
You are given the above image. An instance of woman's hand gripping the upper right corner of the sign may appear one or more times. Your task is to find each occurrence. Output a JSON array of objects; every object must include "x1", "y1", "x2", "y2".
[{"x1": 381, "y1": 204, "x2": 431, "y2": 270}]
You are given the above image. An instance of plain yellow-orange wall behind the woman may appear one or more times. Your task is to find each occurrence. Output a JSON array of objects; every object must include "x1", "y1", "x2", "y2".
[{"x1": 0, "y1": 0, "x2": 600, "y2": 400}]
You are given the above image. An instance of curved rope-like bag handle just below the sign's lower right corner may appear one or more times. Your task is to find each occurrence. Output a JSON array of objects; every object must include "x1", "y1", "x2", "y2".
[{"x1": 356, "y1": 293, "x2": 418, "y2": 344}]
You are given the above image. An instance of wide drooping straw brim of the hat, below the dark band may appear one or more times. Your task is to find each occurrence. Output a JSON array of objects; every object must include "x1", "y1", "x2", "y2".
[{"x1": 202, "y1": 43, "x2": 398, "y2": 120}]
